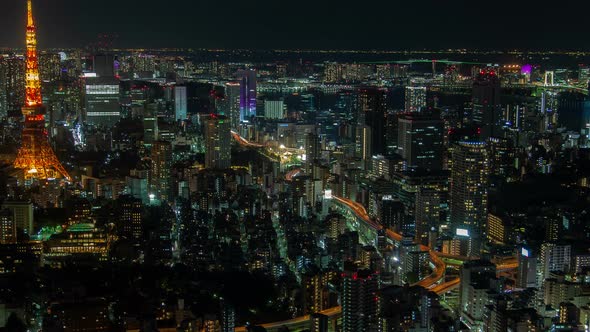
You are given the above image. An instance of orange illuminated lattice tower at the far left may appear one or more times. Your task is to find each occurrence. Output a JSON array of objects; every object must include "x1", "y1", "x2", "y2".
[{"x1": 14, "y1": 0, "x2": 71, "y2": 181}]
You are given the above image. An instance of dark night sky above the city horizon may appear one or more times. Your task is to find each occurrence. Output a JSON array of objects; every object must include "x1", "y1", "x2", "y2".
[{"x1": 0, "y1": 0, "x2": 590, "y2": 50}]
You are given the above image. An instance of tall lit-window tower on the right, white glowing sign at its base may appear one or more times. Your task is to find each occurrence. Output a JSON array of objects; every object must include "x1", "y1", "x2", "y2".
[{"x1": 450, "y1": 141, "x2": 489, "y2": 248}]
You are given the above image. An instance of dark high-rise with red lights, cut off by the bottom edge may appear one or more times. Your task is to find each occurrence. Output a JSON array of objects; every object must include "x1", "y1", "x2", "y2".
[{"x1": 342, "y1": 270, "x2": 379, "y2": 332}]
